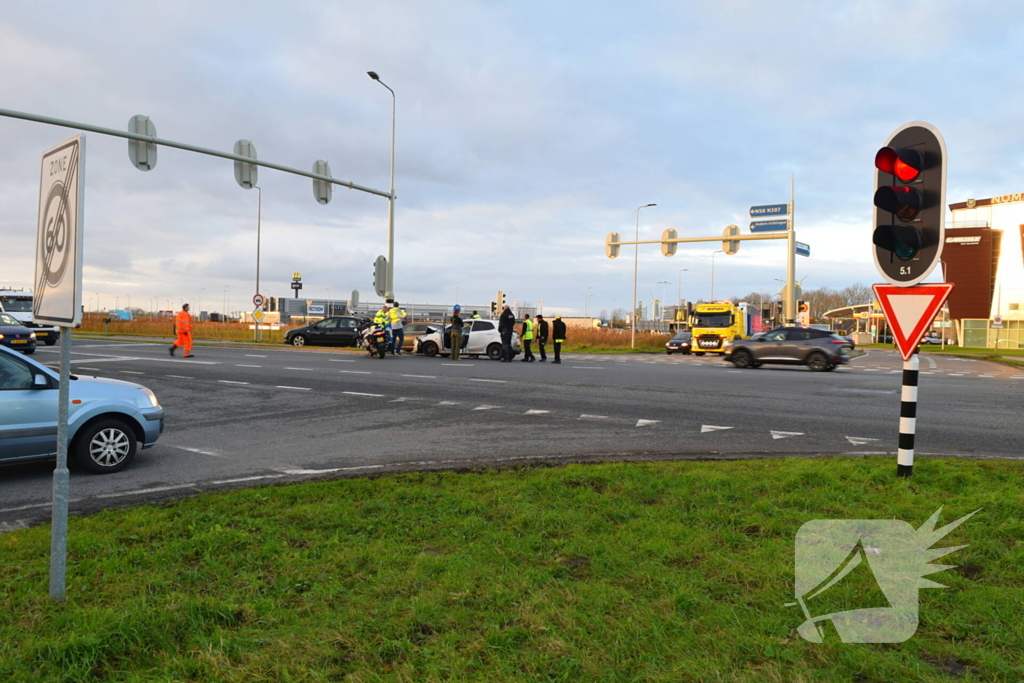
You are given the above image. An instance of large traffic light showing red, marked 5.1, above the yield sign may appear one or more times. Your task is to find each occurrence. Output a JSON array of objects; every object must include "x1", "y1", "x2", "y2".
[{"x1": 871, "y1": 121, "x2": 946, "y2": 287}]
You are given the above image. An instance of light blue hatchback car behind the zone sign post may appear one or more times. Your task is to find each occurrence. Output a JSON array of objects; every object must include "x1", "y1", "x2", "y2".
[{"x1": 0, "y1": 347, "x2": 164, "y2": 474}]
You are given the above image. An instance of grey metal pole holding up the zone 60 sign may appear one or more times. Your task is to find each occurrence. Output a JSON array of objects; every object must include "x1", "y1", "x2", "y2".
[{"x1": 50, "y1": 327, "x2": 72, "y2": 601}]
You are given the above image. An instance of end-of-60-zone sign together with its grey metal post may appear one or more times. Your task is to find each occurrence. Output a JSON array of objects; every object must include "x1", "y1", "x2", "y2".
[{"x1": 32, "y1": 135, "x2": 85, "y2": 600}]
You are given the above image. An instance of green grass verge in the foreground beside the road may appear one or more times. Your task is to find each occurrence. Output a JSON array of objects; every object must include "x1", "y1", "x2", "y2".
[{"x1": 0, "y1": 458, "x2": 1024, "y2": 683}]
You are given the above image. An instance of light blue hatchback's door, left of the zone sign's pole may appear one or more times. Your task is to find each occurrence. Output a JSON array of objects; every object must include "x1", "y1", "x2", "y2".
[{"x1": 0, "y1": 351, "x2": 57, "y2": 460}]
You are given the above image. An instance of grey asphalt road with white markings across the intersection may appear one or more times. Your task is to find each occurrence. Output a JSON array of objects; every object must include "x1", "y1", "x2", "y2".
[{"x1": 0, "y1": 340, "x2": 1024, "y2": 531}]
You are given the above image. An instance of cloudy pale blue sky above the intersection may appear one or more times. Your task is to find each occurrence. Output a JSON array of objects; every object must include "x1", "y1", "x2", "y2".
[{"x1": 0, "y1": 0, "x2": 1024, "y2": 314}]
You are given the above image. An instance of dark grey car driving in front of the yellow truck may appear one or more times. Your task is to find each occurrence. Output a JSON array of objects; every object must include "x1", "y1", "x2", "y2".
[{"x1": 725, "y1": 328, "x2": 849, "y2": 373}]
